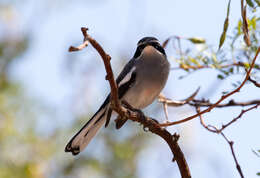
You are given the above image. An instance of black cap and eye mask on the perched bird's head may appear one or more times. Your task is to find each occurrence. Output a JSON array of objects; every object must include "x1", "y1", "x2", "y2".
[{"x1": 134, "y1": 37, "x2": 166, "y2": 58}]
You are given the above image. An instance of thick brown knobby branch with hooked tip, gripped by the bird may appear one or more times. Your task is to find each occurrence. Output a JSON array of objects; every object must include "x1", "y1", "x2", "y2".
[{"x1": 69, "y1": 27, "x2": 191, "y2": 178}]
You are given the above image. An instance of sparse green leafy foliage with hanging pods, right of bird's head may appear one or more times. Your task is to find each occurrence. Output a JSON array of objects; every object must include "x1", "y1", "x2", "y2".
[{"x1": 169, "y1": 5, "x2": 260, "y2": 83}]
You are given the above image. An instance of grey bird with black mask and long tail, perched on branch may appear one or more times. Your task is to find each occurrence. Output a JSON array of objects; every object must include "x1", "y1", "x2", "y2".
[{"x1": 65, "y1": 37, "x2": 170, "y2": 155}]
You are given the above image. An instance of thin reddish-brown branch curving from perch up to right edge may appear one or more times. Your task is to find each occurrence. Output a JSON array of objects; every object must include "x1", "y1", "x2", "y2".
[{"x1": 160, "y1": 47, "x2": 260, "y2": 126}]
